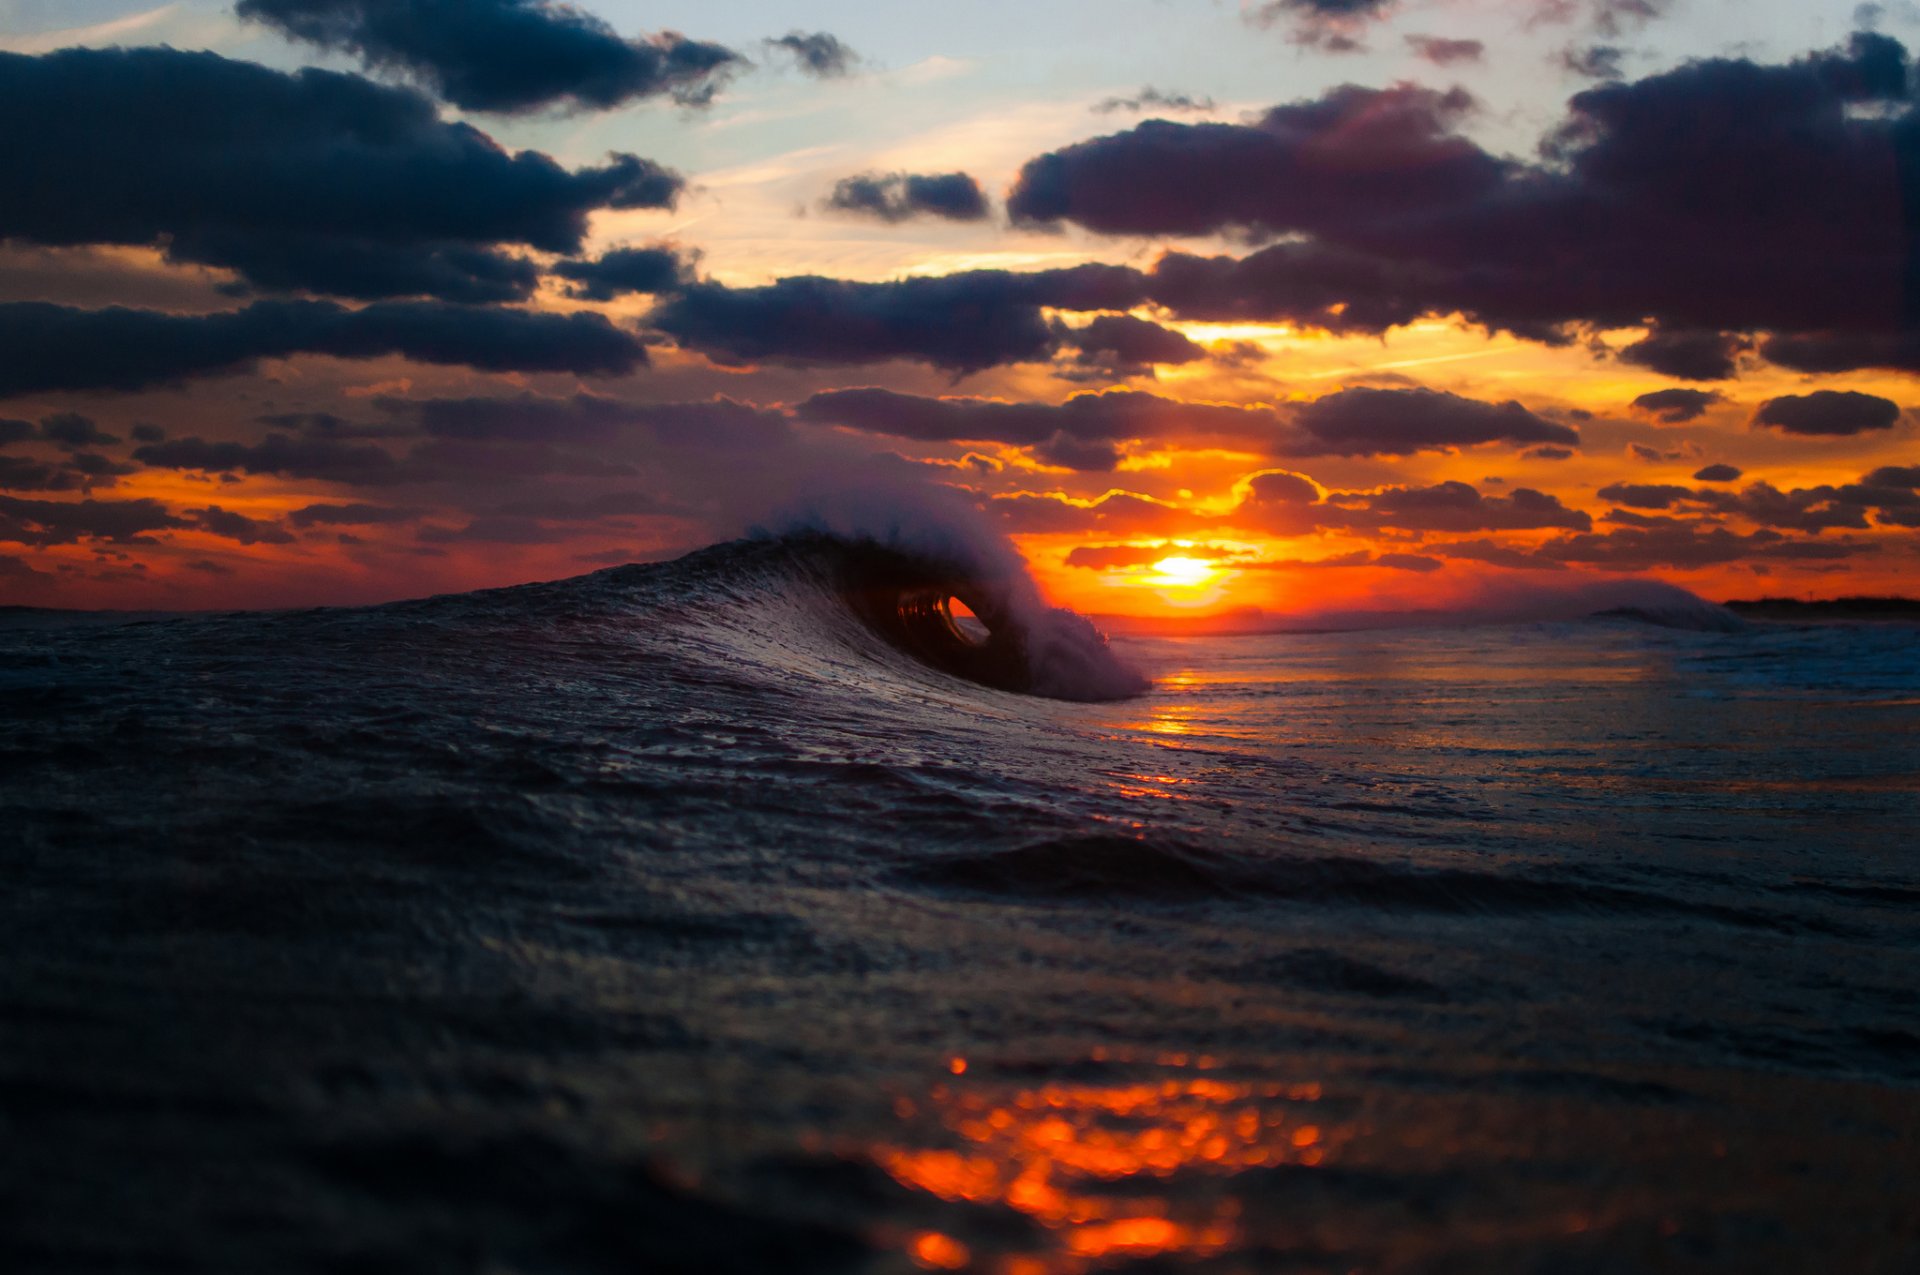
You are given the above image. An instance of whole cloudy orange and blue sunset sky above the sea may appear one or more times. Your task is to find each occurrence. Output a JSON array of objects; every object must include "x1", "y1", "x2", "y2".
[{"x1": 0, "y1": 0, "x2": 1920, "y2": 616}]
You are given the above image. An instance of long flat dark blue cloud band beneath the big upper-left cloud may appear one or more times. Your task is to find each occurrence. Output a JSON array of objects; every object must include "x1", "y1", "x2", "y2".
[{"x1": 0, "y1": 301, "x2": 647, "y2": 396}]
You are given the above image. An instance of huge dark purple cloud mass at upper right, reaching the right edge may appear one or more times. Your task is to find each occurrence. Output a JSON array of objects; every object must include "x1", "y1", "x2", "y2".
[{"x1": 1008, "y1": 35, "x2": 1920, "y2": 362}]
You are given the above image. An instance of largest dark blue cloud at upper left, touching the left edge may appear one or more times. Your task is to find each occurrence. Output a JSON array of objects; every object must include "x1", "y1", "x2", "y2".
[{"x1": 0, "y1": 46, "x2": 682, "y2": 301}]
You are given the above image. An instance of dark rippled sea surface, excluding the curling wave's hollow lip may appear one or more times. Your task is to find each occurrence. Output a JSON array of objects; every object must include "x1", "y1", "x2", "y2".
[{"x1": 0, "y1": 545, "x2": 1920, "y2": 1275}]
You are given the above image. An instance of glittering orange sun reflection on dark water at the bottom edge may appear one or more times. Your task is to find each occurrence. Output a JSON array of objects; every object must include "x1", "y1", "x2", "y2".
[{"x1": 872, "y1": 1056, "x2": 1331, "y2": 1275}]
